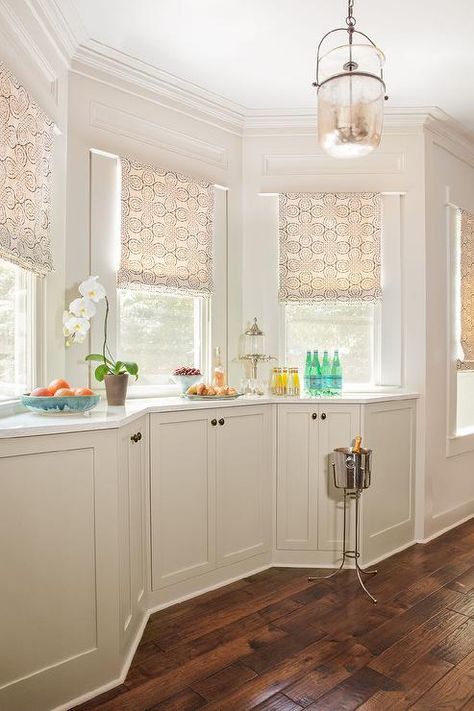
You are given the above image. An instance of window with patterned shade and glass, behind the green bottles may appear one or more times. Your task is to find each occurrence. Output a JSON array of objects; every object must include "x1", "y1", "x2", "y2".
[{"x1": 279, "y1": 193, "x2": 381, "y2": 386}]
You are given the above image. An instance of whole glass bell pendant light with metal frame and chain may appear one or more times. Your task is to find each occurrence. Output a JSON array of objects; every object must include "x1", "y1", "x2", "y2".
[{"x1": 313, "y1": 0, "x2": 388, "y2": 158}]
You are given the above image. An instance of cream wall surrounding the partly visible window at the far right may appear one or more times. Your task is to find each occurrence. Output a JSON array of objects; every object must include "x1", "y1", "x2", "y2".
[{"x1": 425, "y1": 132, "x2": 474, "y2": 536}]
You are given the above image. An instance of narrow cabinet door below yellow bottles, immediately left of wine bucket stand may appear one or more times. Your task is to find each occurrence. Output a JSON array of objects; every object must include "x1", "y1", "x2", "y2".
[{"x1": 276, "y1": 403, "x2": 318, "y2": 550}]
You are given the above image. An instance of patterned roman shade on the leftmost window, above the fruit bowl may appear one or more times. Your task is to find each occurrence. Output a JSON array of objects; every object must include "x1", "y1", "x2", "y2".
[{"x1": 0, "y1": 62, "x2": 53, "y2": 276}]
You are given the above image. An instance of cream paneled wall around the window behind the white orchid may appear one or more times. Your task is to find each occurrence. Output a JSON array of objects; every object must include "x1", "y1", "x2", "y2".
[{"x1": 66, "y1": 72, "x2": 242, "y2": 390}]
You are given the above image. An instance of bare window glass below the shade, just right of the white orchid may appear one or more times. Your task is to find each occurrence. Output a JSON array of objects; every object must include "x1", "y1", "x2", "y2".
[{"x1": 117, "y1": 289, "x2": 207, "y2": 386}]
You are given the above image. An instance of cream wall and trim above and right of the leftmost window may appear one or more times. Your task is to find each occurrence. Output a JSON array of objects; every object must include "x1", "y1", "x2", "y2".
[{"x1": 0, "y1": 0, "x2": 68, "y2": 385}]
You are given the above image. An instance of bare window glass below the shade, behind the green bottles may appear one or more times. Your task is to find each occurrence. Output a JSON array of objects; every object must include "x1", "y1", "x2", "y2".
[{"x1": 283, "y1": 302, "x2": 377, "y2": 385}]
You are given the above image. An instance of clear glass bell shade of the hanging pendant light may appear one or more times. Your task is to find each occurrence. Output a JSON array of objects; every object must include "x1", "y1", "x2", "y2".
[{"x1": 318, "y1": 73, "x2": 385, "y2": 158}]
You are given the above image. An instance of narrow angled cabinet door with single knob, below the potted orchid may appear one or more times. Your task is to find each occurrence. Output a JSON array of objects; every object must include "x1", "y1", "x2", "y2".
[{"x1": 118, "y1": 417, "x2": 148, "y2": 649}]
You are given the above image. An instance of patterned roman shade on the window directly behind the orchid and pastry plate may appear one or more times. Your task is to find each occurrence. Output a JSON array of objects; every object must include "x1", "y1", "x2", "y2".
[{"x1": 117, "y1": 158, "x2": 214, "y2": 296}]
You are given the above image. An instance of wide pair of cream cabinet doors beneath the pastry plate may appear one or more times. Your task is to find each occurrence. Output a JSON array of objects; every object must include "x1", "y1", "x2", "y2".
[{"x1": 151, "y1": 405, "x2": 272, "y2": 591}]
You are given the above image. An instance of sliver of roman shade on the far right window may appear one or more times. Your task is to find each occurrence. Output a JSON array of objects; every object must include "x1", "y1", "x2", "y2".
[{"x1": 458, "y1": 210, "x2": 474, "y2": 370}]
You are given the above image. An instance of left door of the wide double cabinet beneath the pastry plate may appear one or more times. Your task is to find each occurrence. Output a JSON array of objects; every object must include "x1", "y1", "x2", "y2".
[{"x1": 150, "y1": 410, "x2": 218, "y2": 590}]
